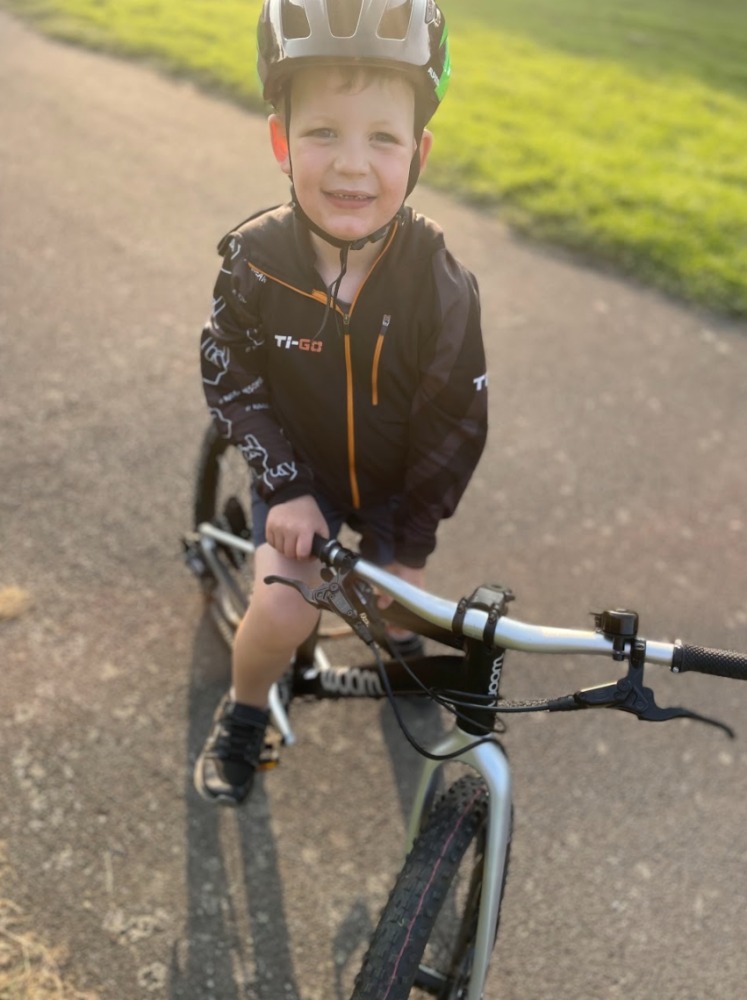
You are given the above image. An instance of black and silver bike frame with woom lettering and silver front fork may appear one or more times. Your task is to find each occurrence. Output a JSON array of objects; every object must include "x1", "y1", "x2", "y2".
[{"x1": 193, "y1": 524, "x2": 512, "y2": 1000}]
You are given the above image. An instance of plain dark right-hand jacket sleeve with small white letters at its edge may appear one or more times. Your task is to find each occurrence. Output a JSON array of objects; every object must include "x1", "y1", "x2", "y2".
[{"x1": 395, "y1": 249, "x2": 488, "y2": 567}]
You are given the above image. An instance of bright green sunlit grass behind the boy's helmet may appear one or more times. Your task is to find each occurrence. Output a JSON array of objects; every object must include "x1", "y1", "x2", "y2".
[{"x1": 5, "y1": 0, "x2": 747, "y2": 317}]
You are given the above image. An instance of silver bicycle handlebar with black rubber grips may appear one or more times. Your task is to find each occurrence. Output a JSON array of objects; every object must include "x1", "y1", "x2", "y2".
[{"x1": 312, "y1": 535, "x2": 747, "y2": 680}]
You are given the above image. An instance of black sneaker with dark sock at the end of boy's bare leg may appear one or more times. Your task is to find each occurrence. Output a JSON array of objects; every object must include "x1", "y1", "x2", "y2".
[{"x1": 194, "y1": 693, "x2": 268, "y2": 806}]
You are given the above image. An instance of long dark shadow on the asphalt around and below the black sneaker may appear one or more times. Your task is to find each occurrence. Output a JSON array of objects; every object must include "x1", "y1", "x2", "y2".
[{"x1": 169, "y1": 615, "x2": 300, "y2": 1000}]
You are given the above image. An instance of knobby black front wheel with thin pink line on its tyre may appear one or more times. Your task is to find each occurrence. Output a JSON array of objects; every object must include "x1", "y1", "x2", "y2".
[{"x1": 352, "y1": 775, "x2": 507, "y2": 1000}]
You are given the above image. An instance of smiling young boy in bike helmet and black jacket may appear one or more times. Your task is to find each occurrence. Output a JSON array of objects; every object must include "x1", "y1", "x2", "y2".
[{"x1": 195, "y1": 0, "x2": 487, "y2": 805}]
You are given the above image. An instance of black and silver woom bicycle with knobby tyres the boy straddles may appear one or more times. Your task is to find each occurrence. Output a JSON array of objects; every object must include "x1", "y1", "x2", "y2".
[{"x1": 185, "y1": 427, "x2": 747, "y2": 1000}]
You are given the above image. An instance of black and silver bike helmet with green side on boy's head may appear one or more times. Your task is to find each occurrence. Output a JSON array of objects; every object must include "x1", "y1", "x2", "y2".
[{"x1": 257, "y1": 0, "x2": 451, "y2": 135}]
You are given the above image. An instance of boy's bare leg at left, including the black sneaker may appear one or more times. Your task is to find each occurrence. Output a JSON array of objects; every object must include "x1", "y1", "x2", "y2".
[{"x1": 194, "y1": 543, "x2": 320, "y2": 805}]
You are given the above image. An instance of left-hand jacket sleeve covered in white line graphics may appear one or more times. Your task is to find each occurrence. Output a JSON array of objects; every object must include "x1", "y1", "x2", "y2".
[{"x1": 200, "y1": 233, "x2": 312, "y2": 505}]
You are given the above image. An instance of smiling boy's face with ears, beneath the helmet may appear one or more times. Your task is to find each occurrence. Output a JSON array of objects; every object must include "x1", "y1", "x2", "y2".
[{"x1": 270, "y1": 68, "x2": 430, "y2": 241}]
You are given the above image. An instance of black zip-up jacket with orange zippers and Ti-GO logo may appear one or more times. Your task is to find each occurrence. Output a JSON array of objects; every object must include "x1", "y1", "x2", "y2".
[{"x1": 202, "y1": 206, "x2": 487, "y2": 566}]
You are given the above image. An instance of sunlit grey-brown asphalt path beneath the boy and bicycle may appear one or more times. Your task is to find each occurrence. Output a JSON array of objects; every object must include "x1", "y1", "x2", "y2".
[{"x1": 0, "y1": 14, "x2": 747, "y2": 1000}]
